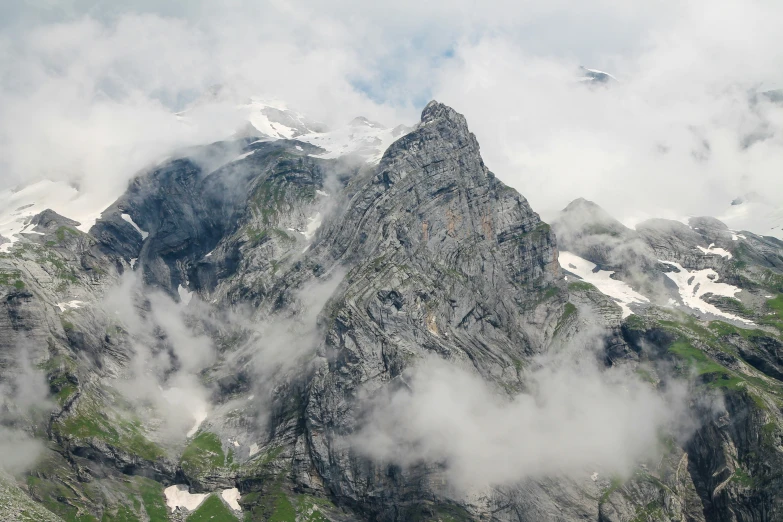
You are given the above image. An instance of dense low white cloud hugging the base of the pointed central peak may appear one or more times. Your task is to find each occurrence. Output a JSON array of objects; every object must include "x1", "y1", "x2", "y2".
[{"x1": 350, "y1": 332, "x2": 685, "y2": 492}]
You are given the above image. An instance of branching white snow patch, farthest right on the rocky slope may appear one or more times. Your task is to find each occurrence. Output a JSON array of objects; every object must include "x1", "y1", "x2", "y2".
[{"x1": 659, "y1": 259, "x2": 753, "y2": 324}]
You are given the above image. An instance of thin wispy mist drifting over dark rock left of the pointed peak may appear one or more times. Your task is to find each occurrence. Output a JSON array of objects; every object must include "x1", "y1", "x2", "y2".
[{"x1": 102, "y1": 264, "x2": 344, "y2": 442}]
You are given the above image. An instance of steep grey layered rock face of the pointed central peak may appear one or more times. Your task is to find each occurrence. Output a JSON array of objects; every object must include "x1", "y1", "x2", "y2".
[{"x1": 298, "y1": 102, "x2": 565, "y2": 519}]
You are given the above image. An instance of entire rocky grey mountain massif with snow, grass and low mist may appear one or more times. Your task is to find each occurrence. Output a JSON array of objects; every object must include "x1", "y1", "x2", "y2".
[{"x1": 0, "y1": 101, "x2": 783, "y2": 521}]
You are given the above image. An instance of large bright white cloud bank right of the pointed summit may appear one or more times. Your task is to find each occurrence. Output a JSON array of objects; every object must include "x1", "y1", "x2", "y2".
[{"x1": 434, "y1": 1, "x2": 783, "y2": 223}]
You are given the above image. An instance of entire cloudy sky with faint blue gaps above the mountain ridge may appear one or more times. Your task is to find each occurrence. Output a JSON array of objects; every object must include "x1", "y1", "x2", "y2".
[{"x1": 0, "y1": 0, "x2": 783, "y2": 228}]
